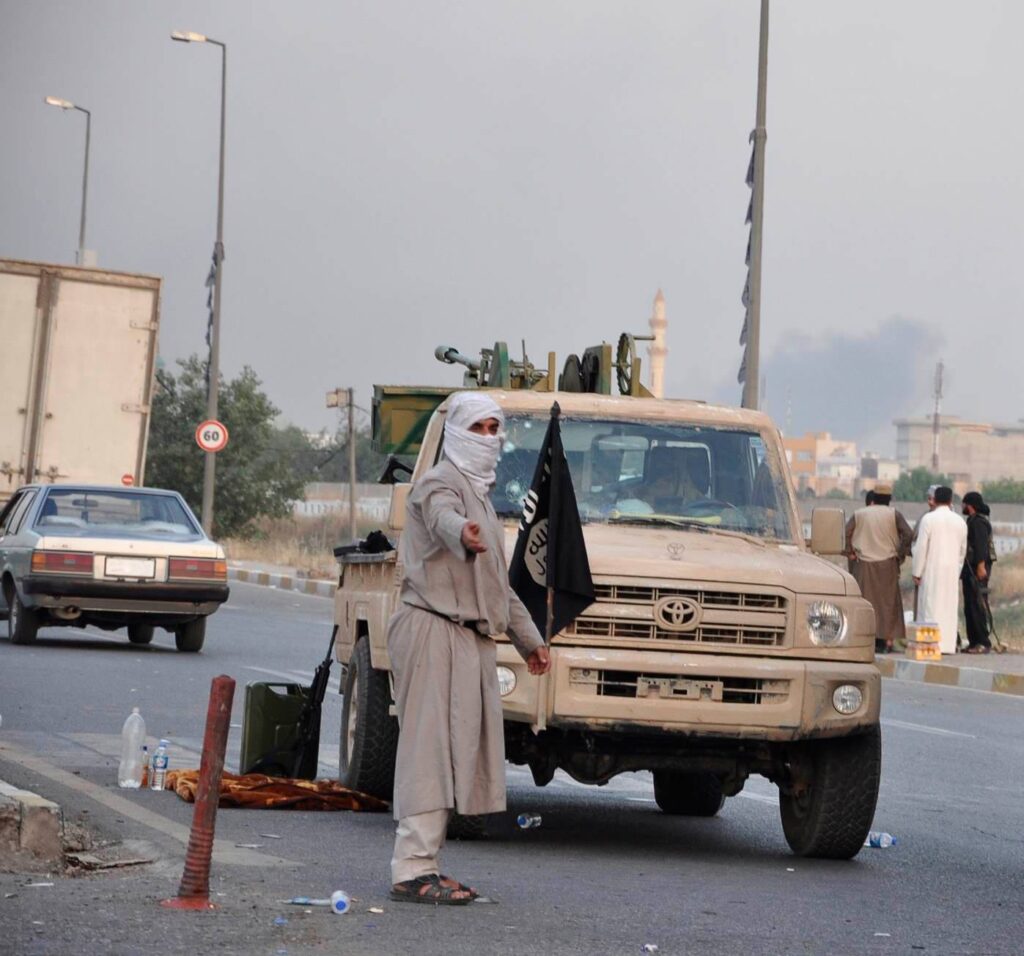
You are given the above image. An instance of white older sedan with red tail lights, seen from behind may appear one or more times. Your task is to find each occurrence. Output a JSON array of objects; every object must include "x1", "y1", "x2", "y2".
[{"x1": 0, "y1": 484, "x2": 228, "y2": 652}]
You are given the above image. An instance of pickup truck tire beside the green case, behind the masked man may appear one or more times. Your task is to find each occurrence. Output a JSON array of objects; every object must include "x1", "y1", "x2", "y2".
[{"x1": 338, "y1": 637, "x2": 398, "y2": 800}]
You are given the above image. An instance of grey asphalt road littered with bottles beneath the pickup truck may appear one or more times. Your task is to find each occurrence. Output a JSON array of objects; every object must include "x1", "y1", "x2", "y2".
[{"x1": 0, "y1": 583, "x2": 1024, "y2": 954}]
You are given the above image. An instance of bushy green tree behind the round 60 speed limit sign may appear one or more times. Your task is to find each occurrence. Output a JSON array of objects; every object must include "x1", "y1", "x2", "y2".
[{"x1": 145, "y1": 355, "x2": 309, "y2": 537}]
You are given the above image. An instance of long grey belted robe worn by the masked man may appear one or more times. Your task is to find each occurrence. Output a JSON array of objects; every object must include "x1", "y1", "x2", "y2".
[{"x1": 387, "y1": 461, "x2": 544, "y2": 819}]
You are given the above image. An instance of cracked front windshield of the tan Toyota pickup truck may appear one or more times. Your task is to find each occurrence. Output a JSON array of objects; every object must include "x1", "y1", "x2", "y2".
[{"x1": 492, "y1": 416, "x2": 793, "y2": 541}]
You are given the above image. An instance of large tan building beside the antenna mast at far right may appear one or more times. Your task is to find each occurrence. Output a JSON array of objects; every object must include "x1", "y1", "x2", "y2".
[{"x1": 893, "y1": 415, "x2": 1024, "y2": 485}]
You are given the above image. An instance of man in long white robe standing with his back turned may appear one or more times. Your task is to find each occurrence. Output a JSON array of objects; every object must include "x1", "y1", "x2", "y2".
[{"x1": 912, "y1": 485, "x2": 967, "y2": 654}]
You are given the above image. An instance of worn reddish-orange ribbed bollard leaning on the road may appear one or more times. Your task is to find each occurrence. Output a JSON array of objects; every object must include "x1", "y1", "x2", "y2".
[{"x1": 160, "y1": 675, "x2": 234, "y2": 910}]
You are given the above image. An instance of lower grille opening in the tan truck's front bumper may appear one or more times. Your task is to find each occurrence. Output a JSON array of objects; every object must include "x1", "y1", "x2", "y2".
[{"x1": 569, "y1": 667, "x2": 790, "y2": 704}]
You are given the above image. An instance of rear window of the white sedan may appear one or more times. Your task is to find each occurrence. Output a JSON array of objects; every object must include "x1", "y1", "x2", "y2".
[{"x1": 33, "y1": 488, "x2": 200, "y2": 538}]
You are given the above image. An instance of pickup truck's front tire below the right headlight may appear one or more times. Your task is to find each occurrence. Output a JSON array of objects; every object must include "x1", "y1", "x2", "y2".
[{"x1": 779, "y1": 727, "x2": 882, "y2": 860}]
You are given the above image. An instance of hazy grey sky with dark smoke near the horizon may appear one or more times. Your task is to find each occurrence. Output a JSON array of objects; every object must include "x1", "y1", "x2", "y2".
[{"x1": 0, "y1": 0, "x2": 1024, "y2": 452}]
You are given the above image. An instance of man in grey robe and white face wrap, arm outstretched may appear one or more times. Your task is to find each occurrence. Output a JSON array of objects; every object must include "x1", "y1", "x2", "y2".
[{"x1": 387, "y1": 392, "x2": 550, "y2": 904}]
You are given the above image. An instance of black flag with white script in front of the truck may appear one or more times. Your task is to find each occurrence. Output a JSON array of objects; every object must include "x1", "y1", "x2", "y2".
[{"x1": 509, "y1": 402, "x2": 594, "y2": 642}]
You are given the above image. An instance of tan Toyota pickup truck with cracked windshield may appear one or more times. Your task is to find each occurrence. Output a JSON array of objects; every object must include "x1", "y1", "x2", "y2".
[{"x1": 335, "y1": 358, "x2": 881, "y2": 858}]
